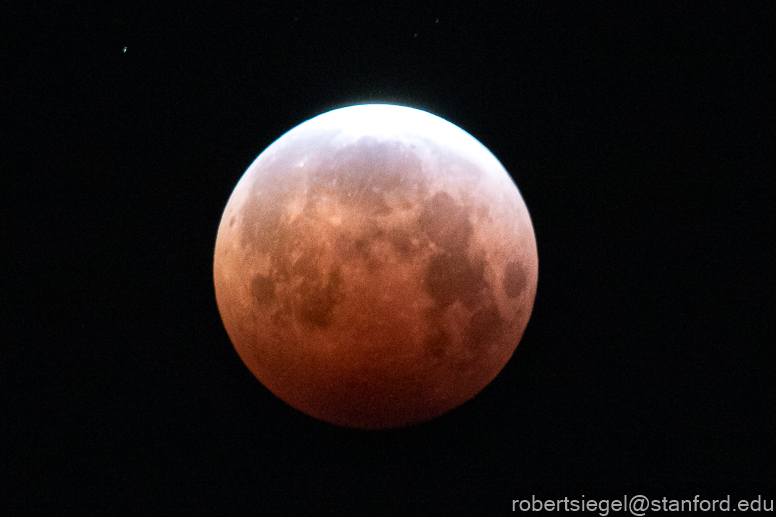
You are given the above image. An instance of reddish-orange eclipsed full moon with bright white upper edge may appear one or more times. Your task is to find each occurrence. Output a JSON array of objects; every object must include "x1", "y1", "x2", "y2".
[{"x1": 213, "y1": 104, "x2": 538, "y2": 429}]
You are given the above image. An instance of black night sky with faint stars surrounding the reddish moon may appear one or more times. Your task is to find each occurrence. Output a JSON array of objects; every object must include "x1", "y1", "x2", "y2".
[{"x1": 7, "y1": 1, "x2": 776, "y2": 515}]
